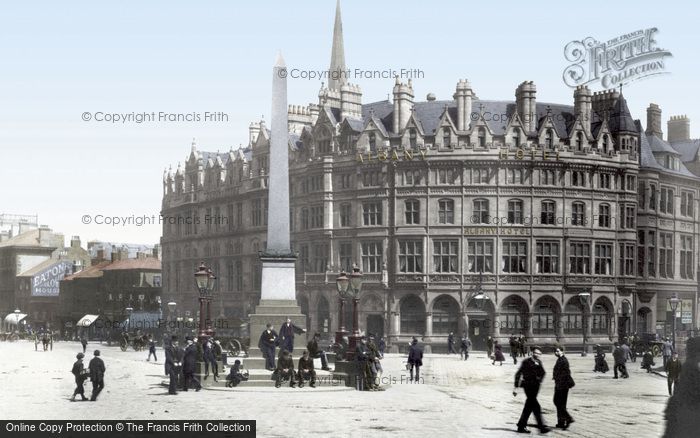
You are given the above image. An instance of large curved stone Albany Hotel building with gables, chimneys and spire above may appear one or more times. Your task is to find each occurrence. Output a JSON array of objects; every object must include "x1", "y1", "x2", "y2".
[{"x1": 162, "y1": 1, "x2": 700, "y2": 349}]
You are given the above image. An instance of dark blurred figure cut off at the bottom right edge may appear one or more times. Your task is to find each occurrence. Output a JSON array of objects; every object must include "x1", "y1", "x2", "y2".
[{"x1": 663, "y1": 337, "x2": 700, "y2": 438}]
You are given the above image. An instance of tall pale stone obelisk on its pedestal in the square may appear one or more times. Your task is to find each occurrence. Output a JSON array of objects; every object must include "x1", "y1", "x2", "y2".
[{"x1": 246, "y1": 54, "x2": 306, "y2": 368}]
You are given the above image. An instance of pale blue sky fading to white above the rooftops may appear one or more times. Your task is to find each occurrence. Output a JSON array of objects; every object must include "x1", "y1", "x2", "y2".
[{"x1": 0, "y1": 0, "x2": 700, "y2": 243}]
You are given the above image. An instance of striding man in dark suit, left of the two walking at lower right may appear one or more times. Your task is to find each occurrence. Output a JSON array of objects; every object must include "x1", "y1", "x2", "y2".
[{"x1": 513, "y1": 347, "x2": 549, "y2": 433}]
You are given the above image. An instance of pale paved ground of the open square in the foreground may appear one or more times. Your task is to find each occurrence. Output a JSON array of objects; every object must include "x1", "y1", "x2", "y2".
[{"x1": 0, "y1": 342, "x2": 668, "y2": 438}]
